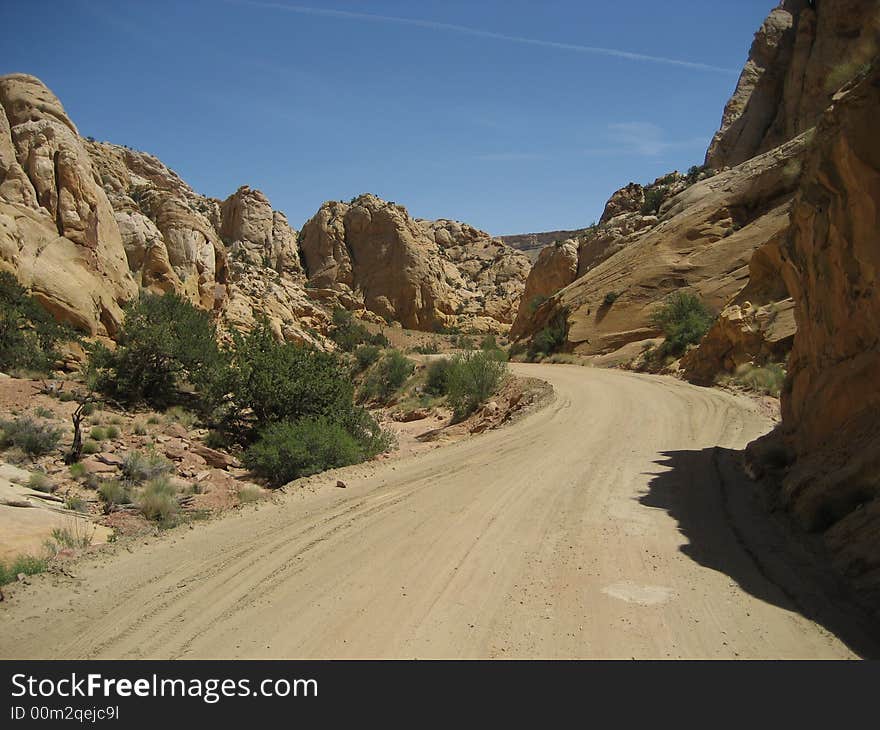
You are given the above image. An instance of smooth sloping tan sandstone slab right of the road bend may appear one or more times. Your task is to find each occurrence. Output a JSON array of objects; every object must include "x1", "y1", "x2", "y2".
[{"x1": 526, "y1": 134, "x2": 809, "y2": 355}]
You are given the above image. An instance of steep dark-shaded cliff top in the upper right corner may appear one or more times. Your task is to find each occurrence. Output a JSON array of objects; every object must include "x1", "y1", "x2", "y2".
[{"x1": 706, "y1": 0, "x2": 880, "y2": 169}]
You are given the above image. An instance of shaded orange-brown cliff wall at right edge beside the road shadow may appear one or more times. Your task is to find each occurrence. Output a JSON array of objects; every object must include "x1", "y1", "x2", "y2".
[{"x1": 755, "y1": 62, "x2": 880, "y2": 606}]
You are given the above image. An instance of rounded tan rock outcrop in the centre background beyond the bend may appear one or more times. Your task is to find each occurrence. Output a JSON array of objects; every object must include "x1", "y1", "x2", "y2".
[{"x1": 301, "y1": 194, "x2": 529, "y2": 331}]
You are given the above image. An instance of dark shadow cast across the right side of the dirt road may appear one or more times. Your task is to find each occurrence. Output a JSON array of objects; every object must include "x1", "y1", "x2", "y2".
[{"x1": 639, "y1": 447, "x2": 880, "y2": 658}]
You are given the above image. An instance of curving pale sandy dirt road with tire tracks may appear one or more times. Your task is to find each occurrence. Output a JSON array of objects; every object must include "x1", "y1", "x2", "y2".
[{"x1": 0, "y1": 365, "x2": 852, "y2": 658}]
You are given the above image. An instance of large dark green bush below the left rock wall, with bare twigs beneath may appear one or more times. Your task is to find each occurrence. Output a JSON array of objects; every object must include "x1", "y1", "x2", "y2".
[{"x1": 88, "y1": 293, "x2": 222, "y2": 407}]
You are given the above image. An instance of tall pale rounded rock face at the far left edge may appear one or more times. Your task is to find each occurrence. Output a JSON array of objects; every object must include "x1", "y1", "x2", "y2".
[{"x1": 0, "y1": 74, "x2": 137, "y2": 336}]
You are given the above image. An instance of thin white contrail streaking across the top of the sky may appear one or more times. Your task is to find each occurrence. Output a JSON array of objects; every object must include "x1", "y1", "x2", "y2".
[{"x1": 227, "y1": 0, "x2": 739, "y2": 75}]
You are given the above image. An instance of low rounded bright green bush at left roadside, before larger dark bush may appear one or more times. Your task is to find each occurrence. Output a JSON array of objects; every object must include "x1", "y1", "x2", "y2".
[{"x1": 244, "y1": 417, "x2": 365, "y2": 487}]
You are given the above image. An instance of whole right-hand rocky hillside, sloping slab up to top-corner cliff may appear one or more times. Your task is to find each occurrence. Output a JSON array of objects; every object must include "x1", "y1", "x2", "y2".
[{"x1": 513, "y1": 0, "x2": 880, "y2": 376}]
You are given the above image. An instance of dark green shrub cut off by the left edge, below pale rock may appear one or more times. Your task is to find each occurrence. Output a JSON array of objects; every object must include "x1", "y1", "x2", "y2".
[{"x1": 0, "y1": 271, "x2": 77, "y2": 373}]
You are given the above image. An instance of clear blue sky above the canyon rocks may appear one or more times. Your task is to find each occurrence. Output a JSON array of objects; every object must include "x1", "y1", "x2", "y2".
[{"x1": 0, "y1": 0, "x2": 773, "y2": 235}]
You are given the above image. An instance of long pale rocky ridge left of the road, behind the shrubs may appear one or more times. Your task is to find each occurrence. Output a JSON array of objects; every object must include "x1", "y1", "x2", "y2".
[{"x1": 0, "y1": 74, "x2": 529, "y2": 342}]
